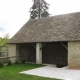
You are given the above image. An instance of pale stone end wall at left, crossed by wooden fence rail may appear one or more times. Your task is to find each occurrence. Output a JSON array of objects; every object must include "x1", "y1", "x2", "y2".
[{"x1": 8, "y1": 44, "x2": 17, "y2": 63}]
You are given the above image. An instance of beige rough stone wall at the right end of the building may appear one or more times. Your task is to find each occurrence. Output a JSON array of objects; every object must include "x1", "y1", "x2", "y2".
[{"x1": 68, "y1": 42, "x2": 80, "y2": 68}]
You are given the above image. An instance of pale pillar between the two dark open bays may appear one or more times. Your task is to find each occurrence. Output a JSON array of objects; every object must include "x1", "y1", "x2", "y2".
[{"x1": 36, "y1": 43, "x2": 42, "y2": 64}]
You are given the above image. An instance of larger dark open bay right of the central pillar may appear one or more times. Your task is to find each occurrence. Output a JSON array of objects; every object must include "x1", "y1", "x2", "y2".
[{"x1": 42, "y1": 42, "x2": 68, "y2": 66}]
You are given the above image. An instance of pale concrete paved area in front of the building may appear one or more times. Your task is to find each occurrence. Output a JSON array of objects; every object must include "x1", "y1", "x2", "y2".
[{"x1": 20, "y1": 65, "x2": 80, "y2": 80}]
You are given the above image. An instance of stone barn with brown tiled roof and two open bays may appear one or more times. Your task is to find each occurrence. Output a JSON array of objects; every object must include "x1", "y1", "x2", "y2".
[{"x1": 8, "y1": 12, "x2": 80, "y2": 67}]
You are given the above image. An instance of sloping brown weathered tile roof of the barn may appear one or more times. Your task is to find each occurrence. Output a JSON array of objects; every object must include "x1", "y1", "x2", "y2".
[{"x1": 9, "y1": 12, "x2": 80, "y2": 43}]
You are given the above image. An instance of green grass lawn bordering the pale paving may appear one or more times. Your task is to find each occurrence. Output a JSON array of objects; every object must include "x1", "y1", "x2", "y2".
[{"x1": 0, "y1": 64, "x2": 59, "y2": 80}]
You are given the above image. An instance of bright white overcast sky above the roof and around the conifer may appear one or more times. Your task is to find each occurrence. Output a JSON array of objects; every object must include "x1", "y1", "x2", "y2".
[{"x1": 0, "y1": 0, "x2": 80, "y2": 38}]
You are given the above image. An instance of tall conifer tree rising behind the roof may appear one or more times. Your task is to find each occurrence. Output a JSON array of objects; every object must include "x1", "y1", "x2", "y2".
[{"x1": 30, "y1": 0, "x2": 49, "y2": 19}]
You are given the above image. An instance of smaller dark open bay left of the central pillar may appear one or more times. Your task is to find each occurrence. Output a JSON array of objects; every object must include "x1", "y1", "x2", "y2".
[{"x1": 19, "y1": 43, "x2": 36, "y2": 63}]
